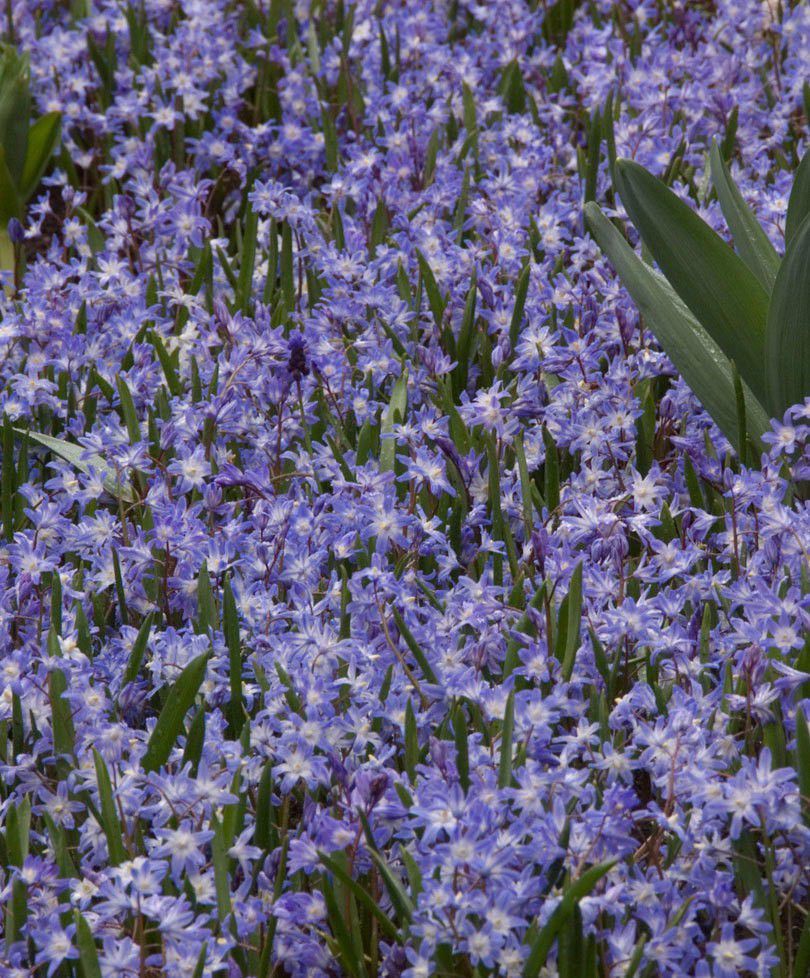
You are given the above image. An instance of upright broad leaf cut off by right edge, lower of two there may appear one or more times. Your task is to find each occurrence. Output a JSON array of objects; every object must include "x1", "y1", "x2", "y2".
[{"x1": 765, "y1": 215, "x2": 810, "y2": 418}]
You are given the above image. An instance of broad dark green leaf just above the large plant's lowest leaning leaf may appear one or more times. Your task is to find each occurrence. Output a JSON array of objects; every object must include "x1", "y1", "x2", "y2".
[{"x1": 616, "y1": 160, "x2": 768, "y2": 400}]
